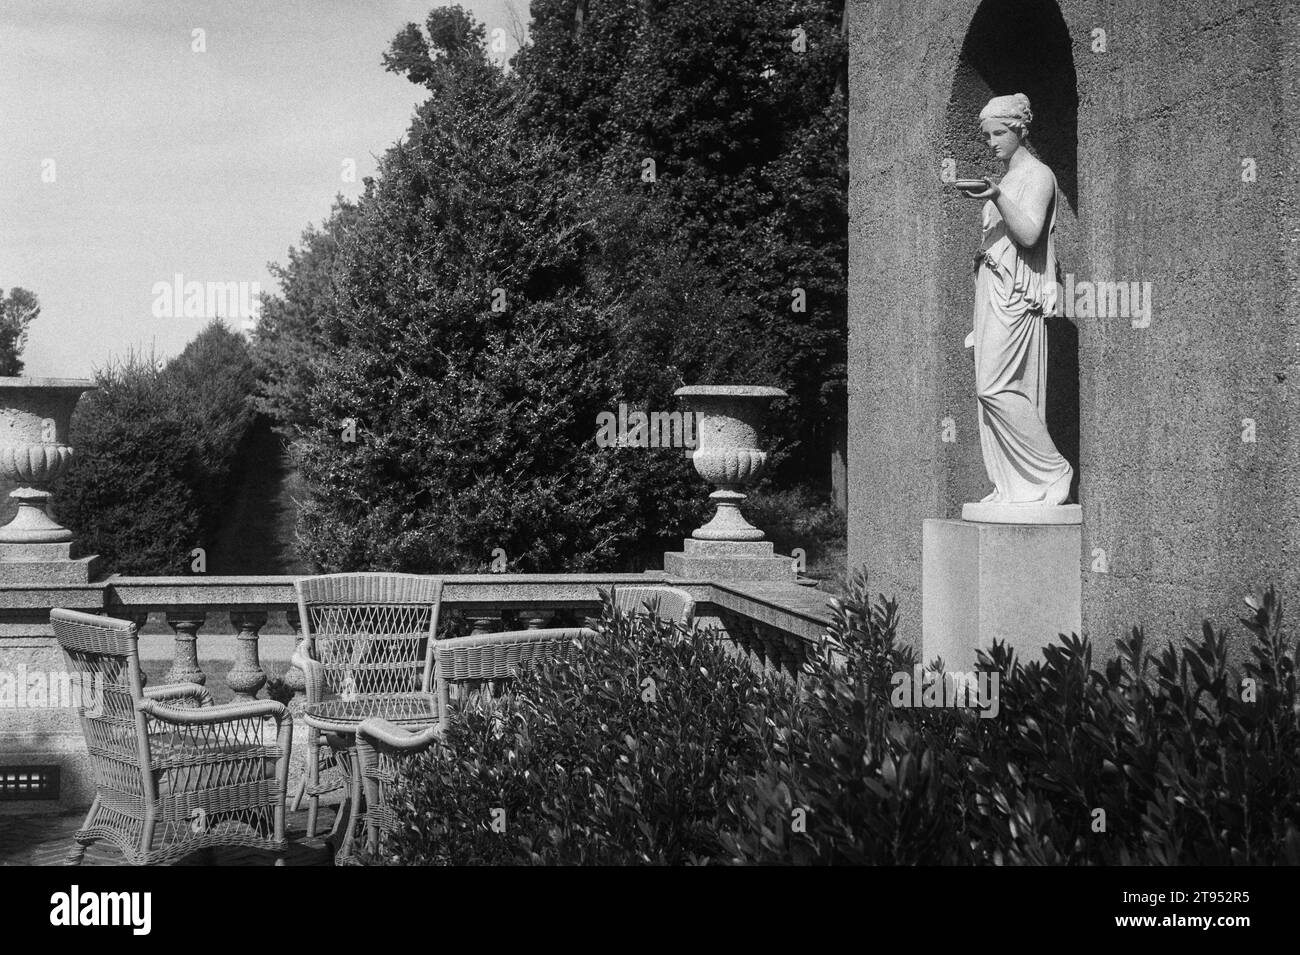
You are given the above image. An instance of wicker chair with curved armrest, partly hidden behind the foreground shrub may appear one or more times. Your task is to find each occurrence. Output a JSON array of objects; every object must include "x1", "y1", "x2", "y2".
[{"x1": 356, "y1": 628, "x2": 598, "y2": 851}]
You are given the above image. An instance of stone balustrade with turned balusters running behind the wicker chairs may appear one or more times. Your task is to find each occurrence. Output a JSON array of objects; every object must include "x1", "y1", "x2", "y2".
[{"x1": 0, "y1": 572, "x2": 827, "y2": 813}]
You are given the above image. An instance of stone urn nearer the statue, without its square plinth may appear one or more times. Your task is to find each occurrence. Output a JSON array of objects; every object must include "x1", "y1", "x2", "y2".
[{"x1": 673, "y1": 385, "x2": 785, "y2": 541}]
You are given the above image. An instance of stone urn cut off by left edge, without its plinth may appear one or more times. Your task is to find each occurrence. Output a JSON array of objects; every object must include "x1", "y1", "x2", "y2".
[{"x1": 0, "y1": 378, "x2": 95, "y2": 544}]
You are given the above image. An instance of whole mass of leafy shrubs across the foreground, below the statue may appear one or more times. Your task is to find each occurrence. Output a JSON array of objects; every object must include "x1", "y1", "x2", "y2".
[{"x1": 386, "y1": 579, "x2": 1300, "y2": 864}]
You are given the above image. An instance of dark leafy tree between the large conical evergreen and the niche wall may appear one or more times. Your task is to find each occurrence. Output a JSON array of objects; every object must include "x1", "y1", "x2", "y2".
[{"x1": 516, "y1": 0, "x2": 848, "y2": 475}]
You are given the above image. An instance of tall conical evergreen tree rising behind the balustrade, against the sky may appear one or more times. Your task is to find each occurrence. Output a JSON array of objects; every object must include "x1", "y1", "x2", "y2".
[{"x1": 298, "y1": 14, "x2": 702, "y2": 572}]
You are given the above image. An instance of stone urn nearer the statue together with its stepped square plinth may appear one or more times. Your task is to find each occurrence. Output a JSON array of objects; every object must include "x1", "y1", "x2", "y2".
[{"x1": 663, "y1": 385, "x2": 794, "y2": 582}]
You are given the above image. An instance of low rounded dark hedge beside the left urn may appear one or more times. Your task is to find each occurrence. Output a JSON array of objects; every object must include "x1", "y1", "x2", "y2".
[{"x1": 53, "y1": 322, "x2": 255, "y2": 574}]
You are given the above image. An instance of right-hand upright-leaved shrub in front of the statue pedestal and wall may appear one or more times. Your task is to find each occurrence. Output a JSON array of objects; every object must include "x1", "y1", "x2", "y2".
[{"x1": 727, "y1": 571, "x2": 1300, "y2": 865}]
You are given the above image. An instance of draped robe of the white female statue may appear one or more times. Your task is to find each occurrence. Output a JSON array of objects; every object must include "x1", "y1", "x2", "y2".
[{"x1": 975, "y1": 162, "x2": 1074, "y2": 504}]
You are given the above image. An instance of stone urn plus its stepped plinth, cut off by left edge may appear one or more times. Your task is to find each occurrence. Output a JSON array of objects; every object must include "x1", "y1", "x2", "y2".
[{"x1": 0, "y1": 378, "x2": 99, "y2": 586}]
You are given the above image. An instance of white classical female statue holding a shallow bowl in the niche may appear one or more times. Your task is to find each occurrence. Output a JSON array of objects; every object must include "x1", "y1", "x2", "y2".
[{"x1": 957, "y1": 94, "x2": 1074, "y2": 520}]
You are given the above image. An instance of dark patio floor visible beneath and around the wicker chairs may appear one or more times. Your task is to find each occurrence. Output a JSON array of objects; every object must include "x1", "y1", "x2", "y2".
[{"x1": 0, "y1": 804, "x2": 335, "y2": 867}]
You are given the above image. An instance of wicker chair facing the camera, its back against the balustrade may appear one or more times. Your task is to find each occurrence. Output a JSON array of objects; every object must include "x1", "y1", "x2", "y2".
[{"x1": 294, "y1": 573, "x2": 442, "y2": 837}]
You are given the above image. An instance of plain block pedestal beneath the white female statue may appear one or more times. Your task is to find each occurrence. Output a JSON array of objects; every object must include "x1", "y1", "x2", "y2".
[{"x1": 920, "y1": 522, "x2": 1083, "y2": 672}]
